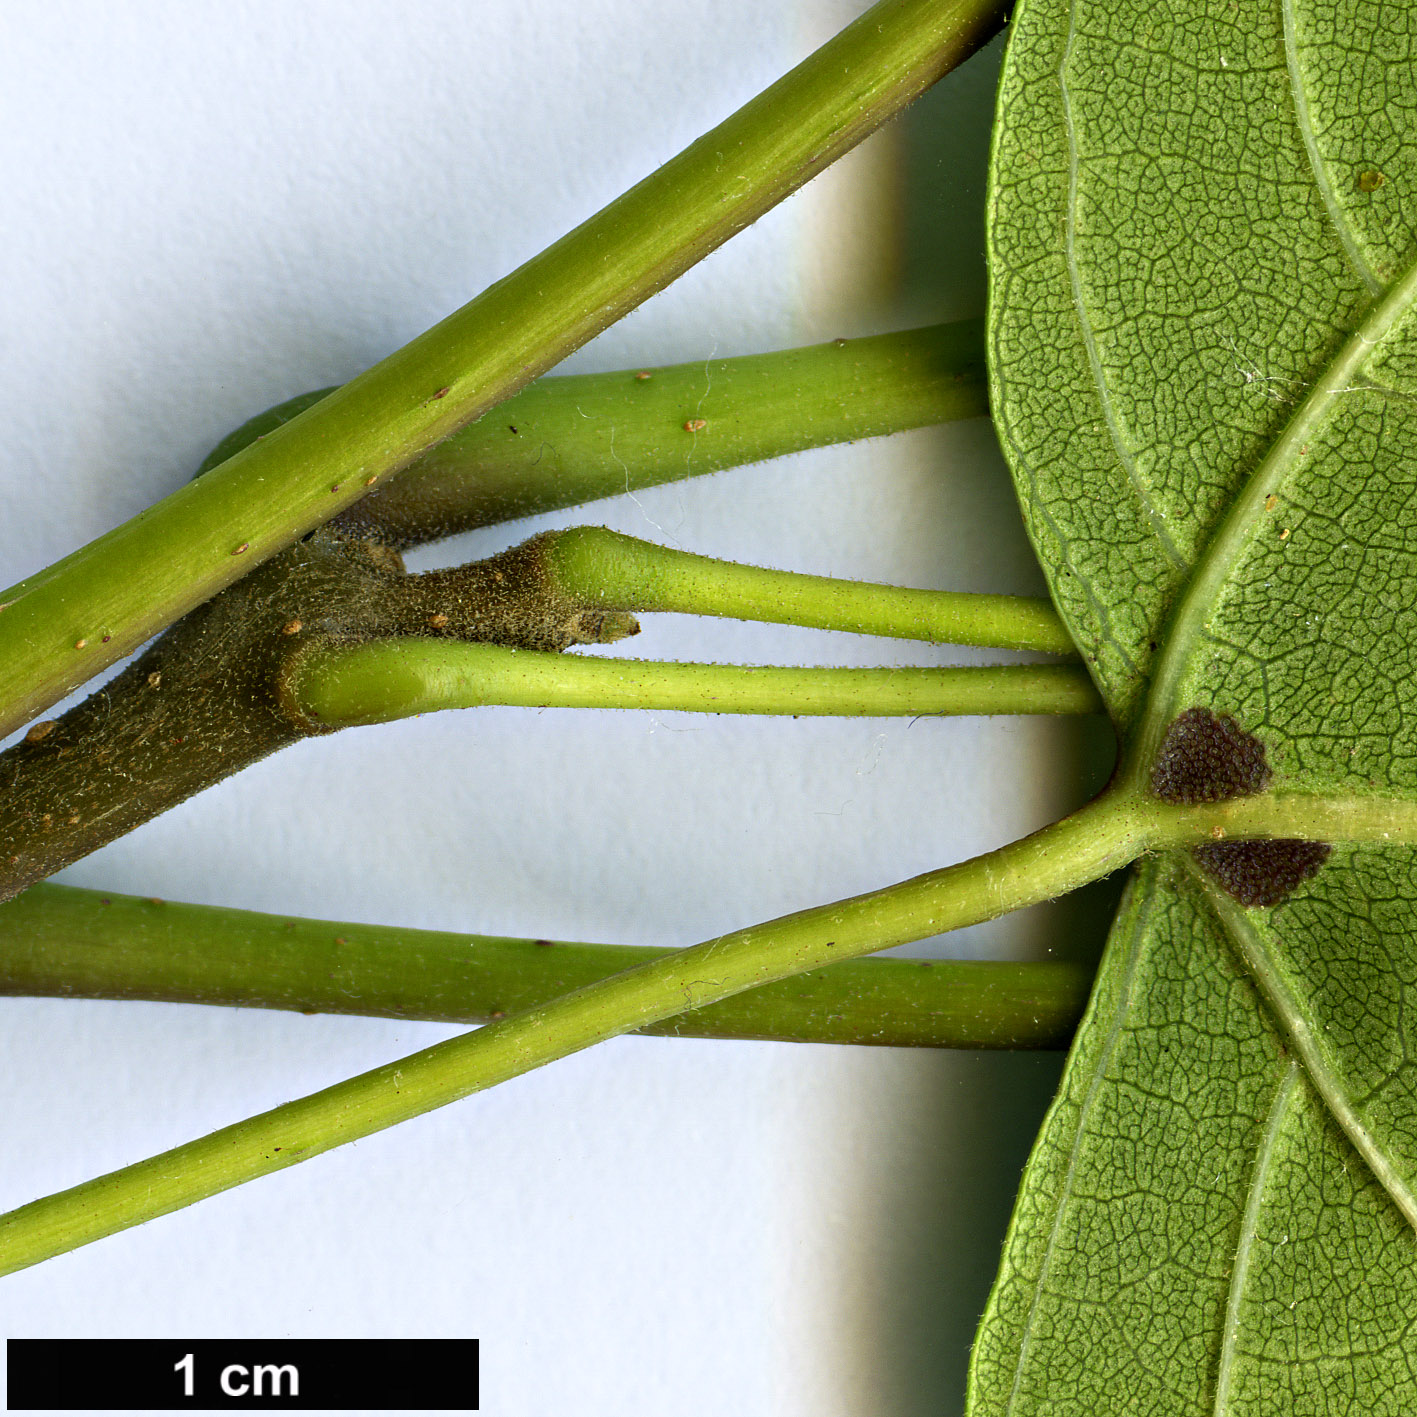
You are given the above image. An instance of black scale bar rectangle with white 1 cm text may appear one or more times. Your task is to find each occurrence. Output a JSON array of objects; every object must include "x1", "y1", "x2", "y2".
[{"x1": 6, "y1": 1338, "x2": 478, "y2": 1413}]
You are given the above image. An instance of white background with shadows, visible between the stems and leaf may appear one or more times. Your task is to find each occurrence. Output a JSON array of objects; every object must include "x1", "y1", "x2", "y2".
[{"x1": 0, "y1": 0, "x2": 1105, "y2": 1417}]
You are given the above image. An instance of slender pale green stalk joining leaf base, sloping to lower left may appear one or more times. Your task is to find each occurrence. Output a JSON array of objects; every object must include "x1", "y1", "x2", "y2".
[{"x1": 0, "y1": 796, "x2": 1146, "y2": 1274}]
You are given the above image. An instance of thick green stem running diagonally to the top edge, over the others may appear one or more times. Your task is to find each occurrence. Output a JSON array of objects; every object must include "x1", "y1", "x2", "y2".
[{"x1": 0, "y1": 0, "x2": 1005, "y2": 735}]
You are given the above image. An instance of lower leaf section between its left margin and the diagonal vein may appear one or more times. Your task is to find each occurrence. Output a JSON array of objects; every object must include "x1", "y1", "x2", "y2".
[{"x1": 973, "y1": 862, "x2": 1417, "y2": 1417}]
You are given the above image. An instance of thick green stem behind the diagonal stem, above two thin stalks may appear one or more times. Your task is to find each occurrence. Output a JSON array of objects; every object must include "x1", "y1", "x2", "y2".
[{"x1": 342, "y1": 320, "x2": 989, "y2": 547}]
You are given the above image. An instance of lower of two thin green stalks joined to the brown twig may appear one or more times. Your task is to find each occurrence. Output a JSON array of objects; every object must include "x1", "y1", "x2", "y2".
[{"x1": 282, "y1": 639, "x2": 1101, "y2": 728}]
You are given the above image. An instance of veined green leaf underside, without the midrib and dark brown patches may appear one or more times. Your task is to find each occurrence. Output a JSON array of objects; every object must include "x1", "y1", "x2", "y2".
[{"x1": 971, "y1": 0, "x2": 1417, "y2": 1417}]
